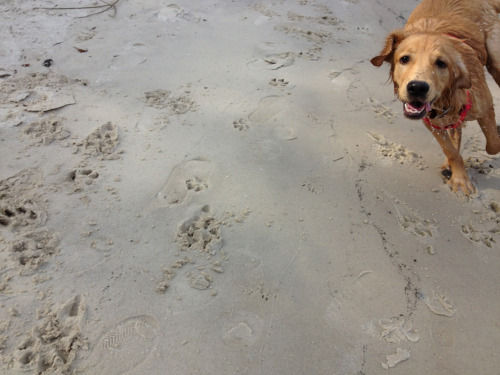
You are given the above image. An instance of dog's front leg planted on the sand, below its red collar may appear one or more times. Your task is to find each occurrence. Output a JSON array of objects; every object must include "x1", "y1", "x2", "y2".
[{"x1": 424, "y1": 122, "x2": 476, "y2": 196}]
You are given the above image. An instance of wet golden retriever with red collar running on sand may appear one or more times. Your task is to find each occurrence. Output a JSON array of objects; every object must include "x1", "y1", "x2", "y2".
[{"x1": 371, "y1": 0, "x2": 500, "y2": 196}]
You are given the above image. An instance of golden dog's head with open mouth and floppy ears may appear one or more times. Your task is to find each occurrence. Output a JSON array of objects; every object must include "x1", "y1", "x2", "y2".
[{"x1": 371, "y1": 30, "x2": 471, "y2": 119}]
